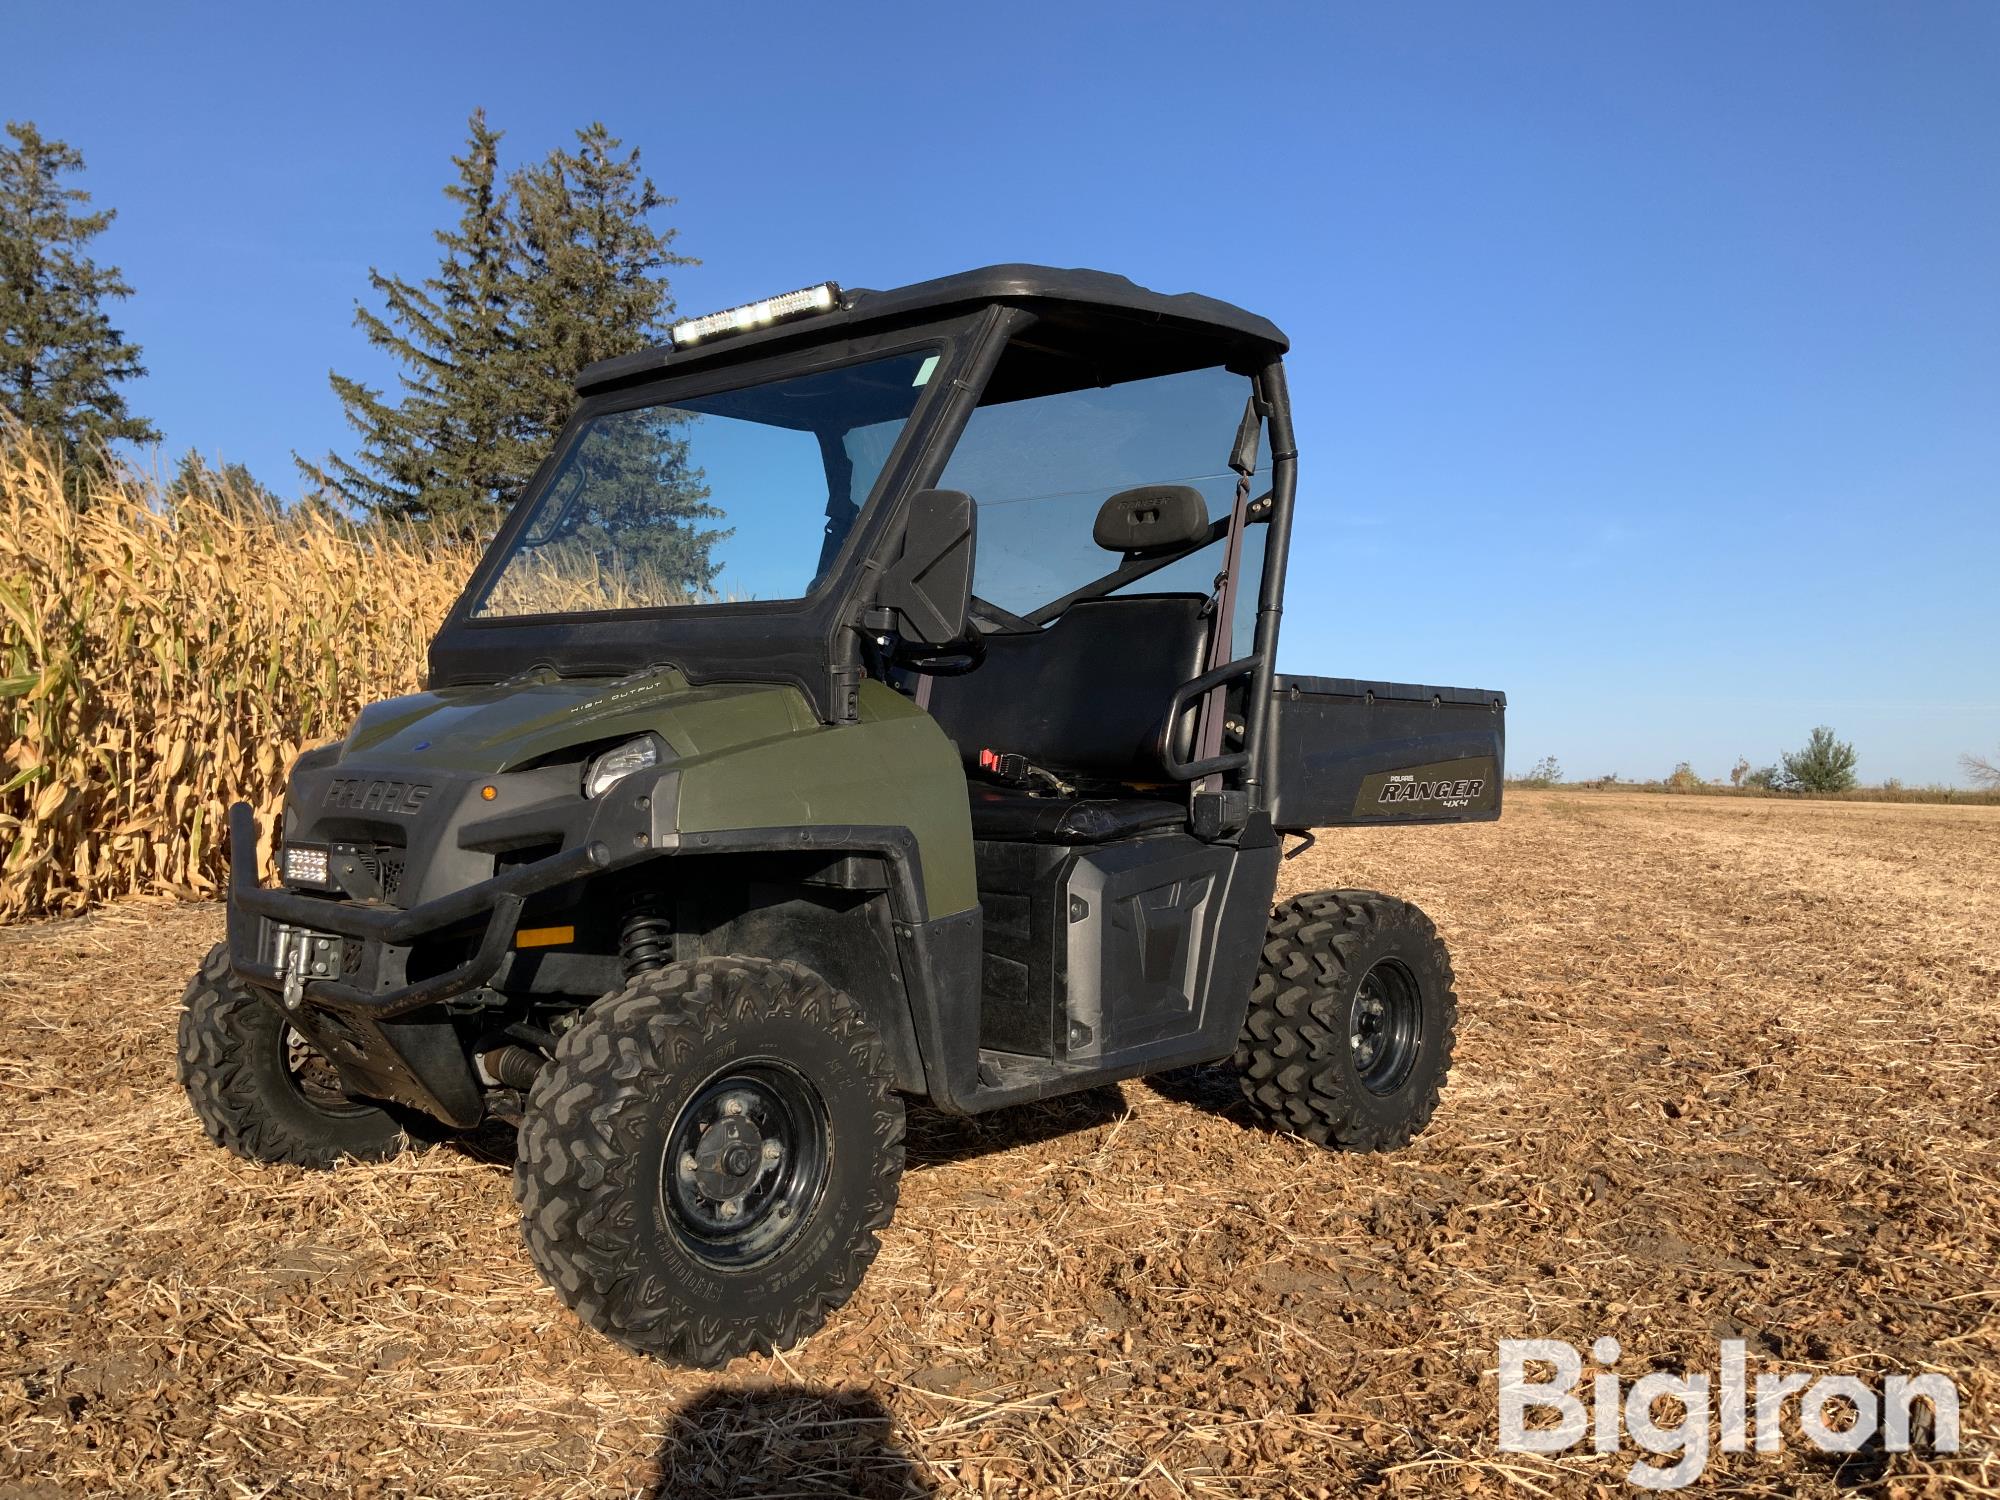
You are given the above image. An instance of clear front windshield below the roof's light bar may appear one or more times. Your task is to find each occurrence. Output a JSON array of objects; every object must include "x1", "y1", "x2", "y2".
[{"x1": 472, "y1": 350, "x2": 938, "y2": 620}]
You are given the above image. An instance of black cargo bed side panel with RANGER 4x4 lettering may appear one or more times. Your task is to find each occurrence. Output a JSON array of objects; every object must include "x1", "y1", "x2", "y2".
[{"x1": 1266, "y1": 676, "x2": 1506, "y2": 830}]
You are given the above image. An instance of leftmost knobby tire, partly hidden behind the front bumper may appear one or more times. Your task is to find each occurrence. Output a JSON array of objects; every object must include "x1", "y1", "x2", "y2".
[{"x1": 180, "y1": 942, "x2": 404, "y2": 1168}]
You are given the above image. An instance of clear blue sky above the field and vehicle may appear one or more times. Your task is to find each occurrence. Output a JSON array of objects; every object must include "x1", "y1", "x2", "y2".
[{"x1": 0, "y1": 0, "x2": 2000, "y2": 782}]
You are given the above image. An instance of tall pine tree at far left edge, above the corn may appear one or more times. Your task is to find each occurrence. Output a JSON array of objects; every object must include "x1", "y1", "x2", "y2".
[{"x1": 0, "y1": 122, "x2": 160, "y2": 472}]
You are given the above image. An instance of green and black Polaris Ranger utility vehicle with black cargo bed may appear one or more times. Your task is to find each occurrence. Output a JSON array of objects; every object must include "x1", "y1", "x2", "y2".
[{"x1": 180, "y1": 266, "x2": 1504, "y2": 1364}]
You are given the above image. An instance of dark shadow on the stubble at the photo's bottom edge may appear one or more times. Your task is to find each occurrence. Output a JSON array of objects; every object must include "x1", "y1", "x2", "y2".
[{"x1": 644, "y1": 1386, "x2": 938, "y2": 1500}]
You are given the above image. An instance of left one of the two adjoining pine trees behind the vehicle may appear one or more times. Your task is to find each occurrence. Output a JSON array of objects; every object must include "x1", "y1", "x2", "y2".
[{"x1": 294, "y1": 110, "x2": 546, "y2": 536}]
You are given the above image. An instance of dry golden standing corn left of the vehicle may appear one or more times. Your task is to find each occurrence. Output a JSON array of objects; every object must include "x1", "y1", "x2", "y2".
[{"x1": 0, "y1": 428, "x2": 476, "y2": 922}]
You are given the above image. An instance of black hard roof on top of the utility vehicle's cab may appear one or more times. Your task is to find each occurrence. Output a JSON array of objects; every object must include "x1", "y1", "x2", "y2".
[{"x1": 576, "y1": 264, "x2": 1290, "y2": 390}]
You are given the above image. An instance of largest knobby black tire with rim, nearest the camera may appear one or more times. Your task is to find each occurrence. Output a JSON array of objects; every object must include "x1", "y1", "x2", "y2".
[{"x1": 514, "y1": 958, "x2": 904, "y2": 1368}]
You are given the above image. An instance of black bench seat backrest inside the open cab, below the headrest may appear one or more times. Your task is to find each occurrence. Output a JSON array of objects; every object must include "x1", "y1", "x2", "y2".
[{"x1": 930, "y1": 594, "x2": 1208, "y2": 782}]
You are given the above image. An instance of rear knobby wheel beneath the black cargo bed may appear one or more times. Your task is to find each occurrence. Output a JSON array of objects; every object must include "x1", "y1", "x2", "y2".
[{"x1": 1236, "y1": 890, "x2": 1458, "y2": 1152}]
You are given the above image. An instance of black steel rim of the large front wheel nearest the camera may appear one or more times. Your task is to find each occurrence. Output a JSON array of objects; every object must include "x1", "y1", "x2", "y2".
[{"x1": 660, "y1": 1060, "x2": 830, "y2": 1270}]
